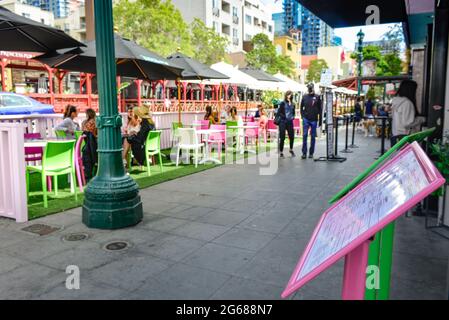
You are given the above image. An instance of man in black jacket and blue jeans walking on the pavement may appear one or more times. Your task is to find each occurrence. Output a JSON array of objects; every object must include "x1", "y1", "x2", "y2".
[{"x1": 301, "y1": 83, "x2": 322, "y2": 159}]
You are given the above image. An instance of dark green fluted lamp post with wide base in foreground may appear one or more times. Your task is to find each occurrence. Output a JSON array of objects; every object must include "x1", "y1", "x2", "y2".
[{"x1": 83, "y1": 1, "x2": 143, "y2": 229}]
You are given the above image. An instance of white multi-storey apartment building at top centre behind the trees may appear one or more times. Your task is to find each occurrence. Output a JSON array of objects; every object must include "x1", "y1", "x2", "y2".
[{"x1": 172, "y1": 0, "x2": 274, "y2": 53}]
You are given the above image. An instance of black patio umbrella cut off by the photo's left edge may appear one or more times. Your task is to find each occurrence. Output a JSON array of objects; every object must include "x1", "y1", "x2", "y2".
[{"x1": 0, "y1": 7, "x2": 84, "y2": 52}]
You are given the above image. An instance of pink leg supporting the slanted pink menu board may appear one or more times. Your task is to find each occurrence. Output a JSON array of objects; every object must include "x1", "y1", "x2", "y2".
[{"x1": 342, "y1": 241, "x2": 370, "y2": 300}]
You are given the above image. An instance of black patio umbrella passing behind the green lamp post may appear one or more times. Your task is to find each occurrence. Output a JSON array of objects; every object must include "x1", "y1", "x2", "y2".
[{"x1": 35, "y1": 34, "x2": 183, "y2": 80}]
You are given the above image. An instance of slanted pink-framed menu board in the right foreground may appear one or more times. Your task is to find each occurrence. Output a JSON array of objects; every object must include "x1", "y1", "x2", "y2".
[{"x1": 282, "y1": 142, "x2": 445, "y2": 298}]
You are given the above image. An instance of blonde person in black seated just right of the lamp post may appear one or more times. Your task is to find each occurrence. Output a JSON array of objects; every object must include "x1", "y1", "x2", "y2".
[{"x1": 123, "y1": 106, "x2": 155, "y2": 166}]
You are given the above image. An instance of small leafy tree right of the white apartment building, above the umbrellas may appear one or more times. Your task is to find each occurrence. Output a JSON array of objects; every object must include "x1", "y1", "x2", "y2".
[{"x1": 246, "y1": 33, "x2": 295, "y2": 76}]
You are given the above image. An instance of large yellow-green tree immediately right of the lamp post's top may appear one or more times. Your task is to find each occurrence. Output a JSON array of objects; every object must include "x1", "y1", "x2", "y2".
[{"x1": 114, "y1": 0, "x2": 193, "y2": 57}]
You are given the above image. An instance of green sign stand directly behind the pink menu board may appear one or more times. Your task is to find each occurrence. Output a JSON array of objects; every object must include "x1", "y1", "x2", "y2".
[{"x1": 329, "y1": 128, "x2": 435, "y2": 300}]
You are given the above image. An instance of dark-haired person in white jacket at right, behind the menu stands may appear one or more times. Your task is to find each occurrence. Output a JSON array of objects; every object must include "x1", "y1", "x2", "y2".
[{"x1": 390, "y1": 80, "x2": 423, "y2": 146}]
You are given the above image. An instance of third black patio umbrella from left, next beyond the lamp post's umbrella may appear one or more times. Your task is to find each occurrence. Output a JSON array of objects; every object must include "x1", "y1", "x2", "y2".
[{"x1": 167, "y1": 52, "x2": 229, "y2": 80}]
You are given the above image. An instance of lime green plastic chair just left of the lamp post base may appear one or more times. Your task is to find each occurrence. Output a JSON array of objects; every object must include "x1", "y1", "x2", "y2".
[{"x1": 26, "y1": 140, "x2": 78, "y2": 208}]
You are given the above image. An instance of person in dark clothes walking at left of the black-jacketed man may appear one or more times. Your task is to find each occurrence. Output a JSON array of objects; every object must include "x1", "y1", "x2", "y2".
[{"x1": 276, "y1": 91, "x2": 296, "y2": 158}]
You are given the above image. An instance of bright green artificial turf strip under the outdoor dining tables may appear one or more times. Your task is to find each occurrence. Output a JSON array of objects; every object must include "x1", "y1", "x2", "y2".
[{"x1": 28, "y1": 146, "x2": 270, "y2": 220}]
